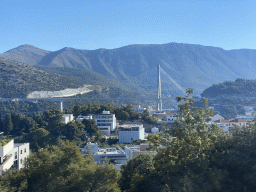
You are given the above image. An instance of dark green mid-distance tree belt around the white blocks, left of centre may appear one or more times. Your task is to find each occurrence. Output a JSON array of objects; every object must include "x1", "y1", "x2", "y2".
[{"x1": 0, "y1": 104, "x2": 156, "y2": 150}]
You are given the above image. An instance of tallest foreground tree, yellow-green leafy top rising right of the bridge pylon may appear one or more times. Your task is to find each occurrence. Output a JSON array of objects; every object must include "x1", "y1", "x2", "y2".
[{"x1": 148, "y1": 89, "x2": 225, "y2": 191}]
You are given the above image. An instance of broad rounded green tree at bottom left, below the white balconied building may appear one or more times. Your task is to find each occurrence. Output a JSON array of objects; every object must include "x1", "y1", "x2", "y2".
[{"x1": 1, "y1": 141, "x2": 120, "y2": 192}]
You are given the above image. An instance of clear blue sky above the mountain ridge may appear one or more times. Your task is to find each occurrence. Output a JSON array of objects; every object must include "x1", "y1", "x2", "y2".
[{"x1": 0, "y1": 0, "x2": 256, "y2": 53}]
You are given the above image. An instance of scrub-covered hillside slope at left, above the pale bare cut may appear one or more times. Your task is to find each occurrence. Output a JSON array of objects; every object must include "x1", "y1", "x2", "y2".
[{"x1": 0, "y1": 59, "x2": 82, "y2": 98}]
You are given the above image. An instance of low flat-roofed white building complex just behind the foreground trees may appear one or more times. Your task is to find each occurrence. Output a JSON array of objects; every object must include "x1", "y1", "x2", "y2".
[{"x1": 82, "y1": 142, "x2": 127, "y2": 171}]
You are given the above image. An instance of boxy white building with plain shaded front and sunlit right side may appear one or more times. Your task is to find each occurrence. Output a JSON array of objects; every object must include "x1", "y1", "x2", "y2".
[{"x1": 119, "y1": 124, "x2": 145, "y2": 143}]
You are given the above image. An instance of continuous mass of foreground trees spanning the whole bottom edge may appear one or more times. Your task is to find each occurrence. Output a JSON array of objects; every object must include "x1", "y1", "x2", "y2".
[{"x1": 0, "y1": 89, "x2": 256, "y2": 192}]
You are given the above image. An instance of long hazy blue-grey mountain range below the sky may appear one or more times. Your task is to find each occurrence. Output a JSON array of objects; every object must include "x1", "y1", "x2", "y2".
[{"x1": 0, "y1": 43, "x2": 256, "y2": 96}]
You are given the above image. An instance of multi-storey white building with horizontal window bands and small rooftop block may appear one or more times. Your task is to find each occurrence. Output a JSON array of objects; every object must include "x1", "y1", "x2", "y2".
[{"x1": 95, "y1": 110, "x2": 116, "y2": 135}]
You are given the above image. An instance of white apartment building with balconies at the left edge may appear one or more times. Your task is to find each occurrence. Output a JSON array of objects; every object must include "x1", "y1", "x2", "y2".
[{"x1": 0, "y1": 139, "x2": 29, "y2": 174}]
